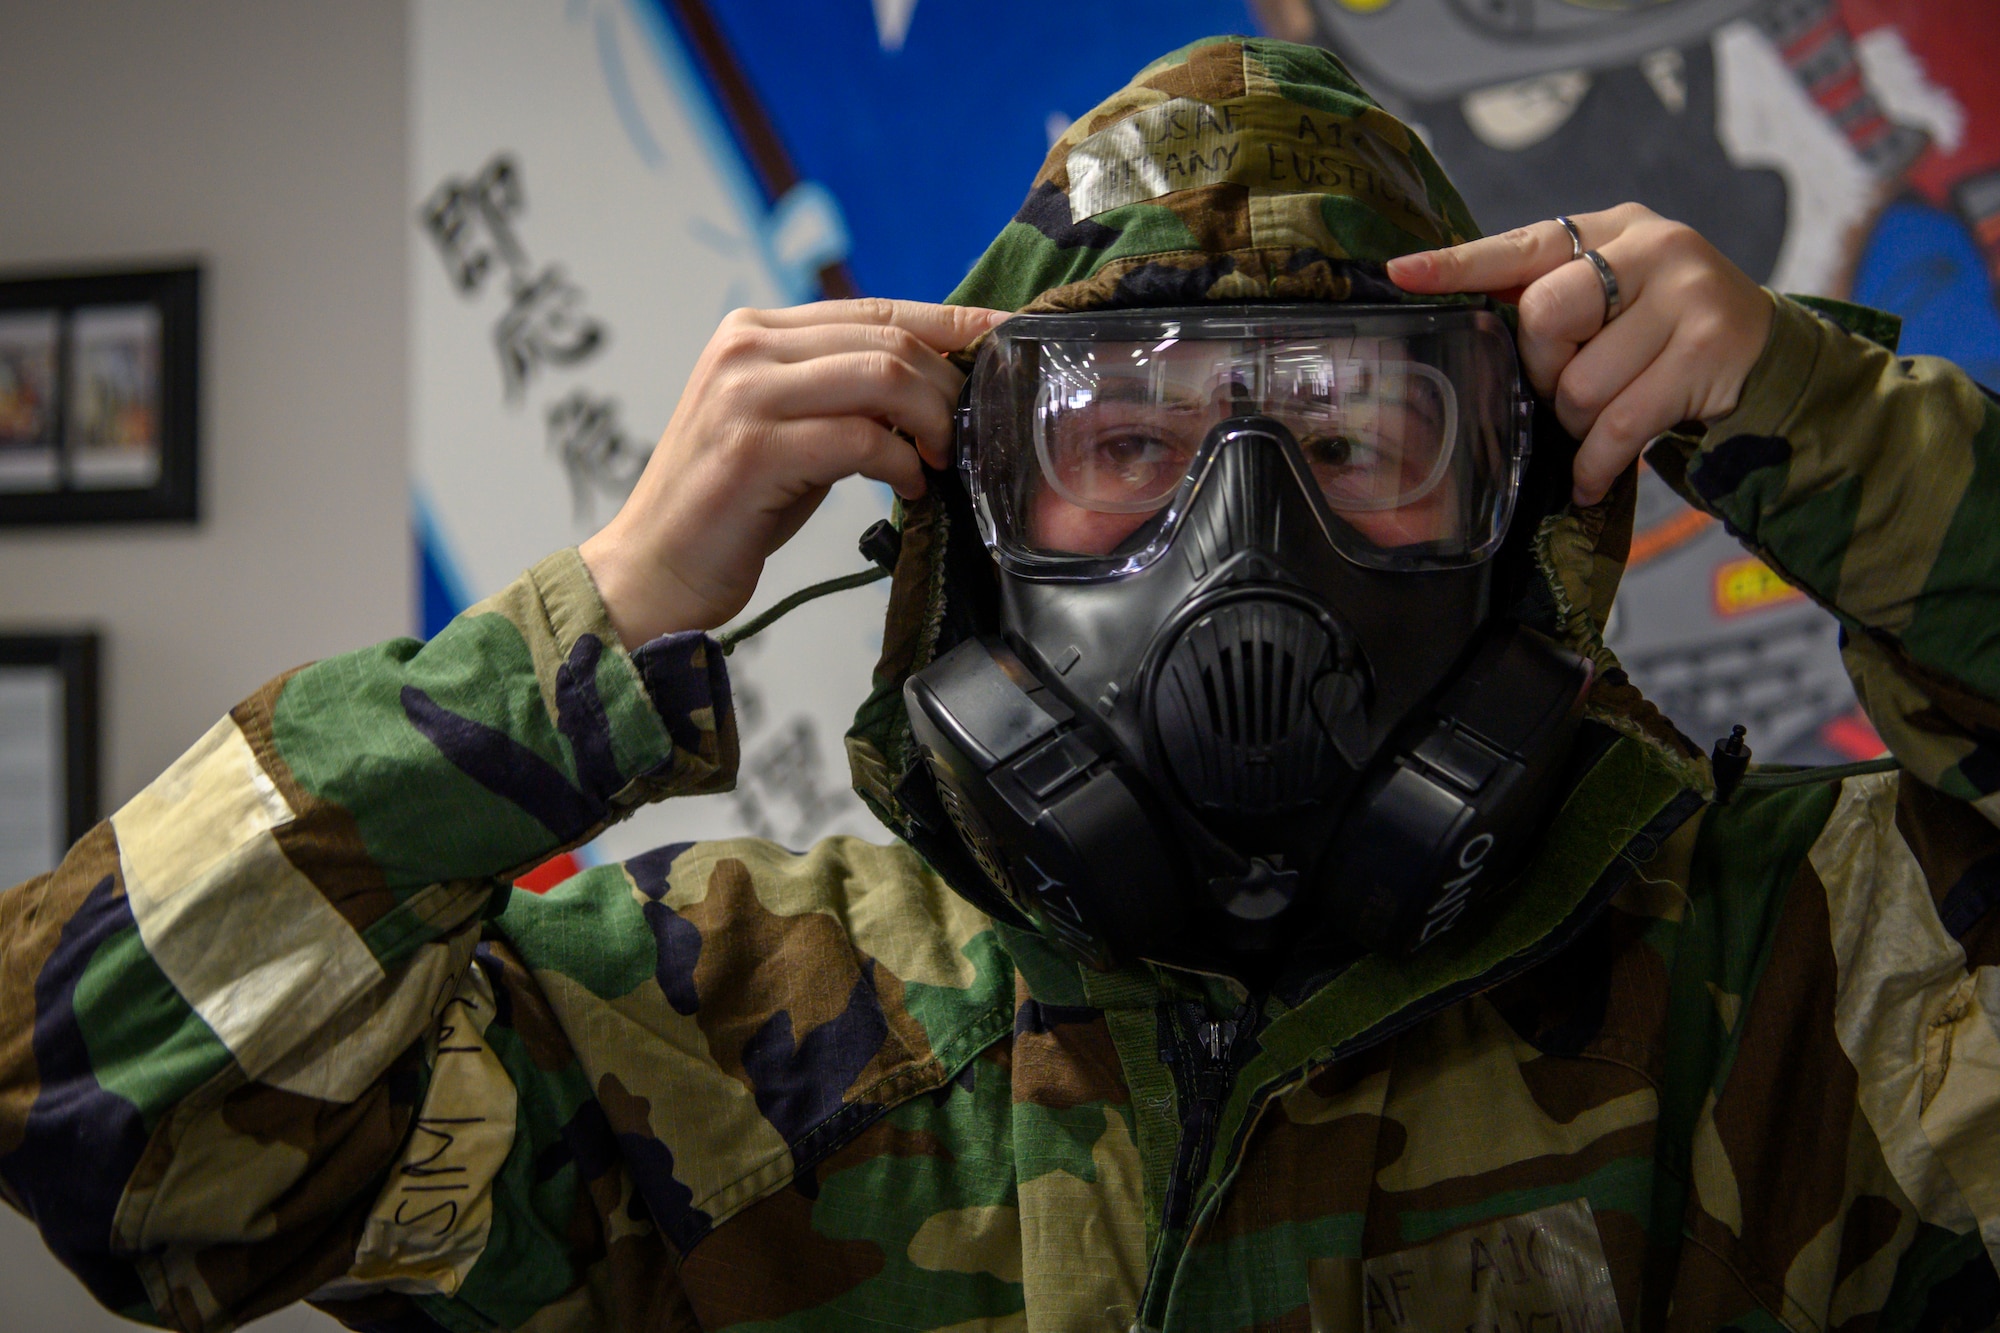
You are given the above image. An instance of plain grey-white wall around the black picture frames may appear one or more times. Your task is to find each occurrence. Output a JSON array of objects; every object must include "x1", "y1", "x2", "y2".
[{"x1": 0, "y1": 0, "x2": 414, "y2": 1333}]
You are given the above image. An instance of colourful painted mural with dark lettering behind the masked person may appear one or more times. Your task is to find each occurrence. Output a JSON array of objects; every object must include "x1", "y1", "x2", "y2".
[{"x1": 410, "y1": 0, "x2": 2000, "y2": 883}]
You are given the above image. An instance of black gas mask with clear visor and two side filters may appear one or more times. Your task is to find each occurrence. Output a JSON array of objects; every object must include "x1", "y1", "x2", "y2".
[{"x1": 904, "y1": 304, "x2": 1590, "y2": 975}]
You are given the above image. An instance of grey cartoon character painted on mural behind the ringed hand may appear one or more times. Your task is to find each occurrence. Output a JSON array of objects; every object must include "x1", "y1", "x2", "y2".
[{"x1": 1258, "y1": 0, "x2": 2000, "y2": 763}]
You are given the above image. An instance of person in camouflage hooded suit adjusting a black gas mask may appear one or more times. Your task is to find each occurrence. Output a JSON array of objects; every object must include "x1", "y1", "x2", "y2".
[{"x1": 0, "y1": 38, "x2": 2000, "y2": 1333}]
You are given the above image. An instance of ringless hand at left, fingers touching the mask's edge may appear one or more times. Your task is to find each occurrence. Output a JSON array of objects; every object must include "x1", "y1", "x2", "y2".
[{"x1": 580, "y1": 298, "x2": 1006, "y2": 648}]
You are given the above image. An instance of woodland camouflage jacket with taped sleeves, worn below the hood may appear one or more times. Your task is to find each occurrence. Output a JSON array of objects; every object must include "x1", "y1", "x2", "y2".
[{"x1": 11, "y1": 36, "x2": 2000, "y2": 1333}]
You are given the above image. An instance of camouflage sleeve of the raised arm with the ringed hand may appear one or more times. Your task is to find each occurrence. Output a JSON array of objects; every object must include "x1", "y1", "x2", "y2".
[{"x1": 1648, "y1": 296, "x2": 2000, "y2": 823}]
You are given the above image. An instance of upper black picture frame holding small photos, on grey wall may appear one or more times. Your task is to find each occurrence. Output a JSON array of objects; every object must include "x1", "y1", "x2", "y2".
[{"x1": 0, "y1": 268, "x2": 200, "y2": 524}]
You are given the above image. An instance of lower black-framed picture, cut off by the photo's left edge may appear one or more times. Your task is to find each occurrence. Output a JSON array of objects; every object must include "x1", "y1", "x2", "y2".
[{"x1": 0, "y1": 630, "x2": 98, "y2": 889}]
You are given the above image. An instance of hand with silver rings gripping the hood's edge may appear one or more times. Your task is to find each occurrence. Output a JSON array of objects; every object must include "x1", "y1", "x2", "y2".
[{"x1": 1388, "y1": 204, "x2": 1772, "y2": 504}]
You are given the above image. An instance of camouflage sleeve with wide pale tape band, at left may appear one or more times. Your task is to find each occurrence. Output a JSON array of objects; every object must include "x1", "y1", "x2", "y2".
[{"x1": 0, "y1": 550, "x2": 736, "y2": 1331}]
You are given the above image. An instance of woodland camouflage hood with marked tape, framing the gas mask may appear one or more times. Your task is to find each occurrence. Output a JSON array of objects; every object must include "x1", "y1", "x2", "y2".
[{"x1": 848, "y1": 36, "x2": 1708, "y2": 915}]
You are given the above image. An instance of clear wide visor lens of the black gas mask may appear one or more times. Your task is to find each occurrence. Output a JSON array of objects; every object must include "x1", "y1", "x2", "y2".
[{"x1": 958, "y1": 304, "x2": 1530, "y2": 576}]
